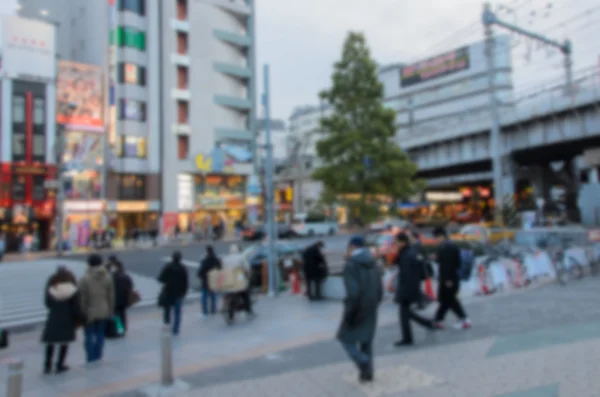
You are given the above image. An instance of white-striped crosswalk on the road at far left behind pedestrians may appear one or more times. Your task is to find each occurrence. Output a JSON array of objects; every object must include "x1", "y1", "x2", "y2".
[{"x1": 0, "y1": 259, "x2": 160, "y2": 329}]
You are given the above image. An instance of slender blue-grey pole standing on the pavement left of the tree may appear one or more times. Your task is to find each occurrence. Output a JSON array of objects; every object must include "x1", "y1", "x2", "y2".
[{"x1": 262, "y1": 64, "x2": 279, "y2": 297}]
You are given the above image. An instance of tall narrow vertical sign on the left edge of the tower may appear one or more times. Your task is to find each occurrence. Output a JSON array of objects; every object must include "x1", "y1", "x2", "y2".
[{"x1": 107, "y1": 0, "x2": 118, "y2": 145}]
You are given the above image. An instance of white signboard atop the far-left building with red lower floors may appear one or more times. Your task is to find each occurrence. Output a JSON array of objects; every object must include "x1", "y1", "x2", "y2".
[{"x1": 2, "y1": 16, "x2": 56, "y2": 81}]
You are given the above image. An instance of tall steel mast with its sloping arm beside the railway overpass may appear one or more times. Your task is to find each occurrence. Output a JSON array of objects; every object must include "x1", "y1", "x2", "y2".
[{"x1": 481, "y1": 3, "x2": 573, "y2": 223}]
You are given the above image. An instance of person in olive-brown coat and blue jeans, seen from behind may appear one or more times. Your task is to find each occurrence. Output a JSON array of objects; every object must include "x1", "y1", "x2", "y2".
[{"x1": 79, "y1": 254, "x2": 115, "y2": 363}]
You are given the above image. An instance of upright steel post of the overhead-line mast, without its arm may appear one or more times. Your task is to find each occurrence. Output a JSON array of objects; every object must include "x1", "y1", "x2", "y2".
[{"x1": 483, "y1": 3, "x2": 504, "y2": 223}]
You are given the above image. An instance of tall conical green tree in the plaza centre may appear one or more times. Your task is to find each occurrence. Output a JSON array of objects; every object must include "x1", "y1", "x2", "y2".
[{"x1": 313, "y1": 32, "x2": 422, "y2": 223}]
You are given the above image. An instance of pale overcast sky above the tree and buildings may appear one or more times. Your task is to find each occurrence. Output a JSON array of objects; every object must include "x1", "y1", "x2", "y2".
[{"x1": 0, "y1": 0, "x2": 600, "y2": 120}]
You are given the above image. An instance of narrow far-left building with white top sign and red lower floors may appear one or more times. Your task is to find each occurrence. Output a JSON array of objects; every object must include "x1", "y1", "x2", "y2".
[{"x1": 0, "y1": 17, "x2": 56, "y2": 251}]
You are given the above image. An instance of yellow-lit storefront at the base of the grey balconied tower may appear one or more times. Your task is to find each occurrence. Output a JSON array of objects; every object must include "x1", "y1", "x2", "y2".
[{"x1": 194, "y1": 174, "x2": 247, "y2": 230}]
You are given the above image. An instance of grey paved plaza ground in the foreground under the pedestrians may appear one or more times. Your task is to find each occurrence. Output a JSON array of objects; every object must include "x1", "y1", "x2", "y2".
[{"x1": 0, "y1": 278, "x2": 600, "y2": 397}]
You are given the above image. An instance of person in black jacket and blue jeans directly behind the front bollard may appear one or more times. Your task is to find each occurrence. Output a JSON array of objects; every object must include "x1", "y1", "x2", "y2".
[{"x1": 158, "y1": 251, "x2": 189, "y2": 335}]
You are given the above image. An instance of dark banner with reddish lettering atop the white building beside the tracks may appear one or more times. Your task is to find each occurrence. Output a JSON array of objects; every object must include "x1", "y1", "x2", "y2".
[{"x1": 400, "y1": 47, "x2": 469, "y2": 88}]
